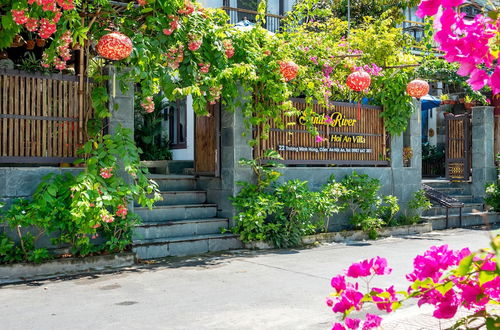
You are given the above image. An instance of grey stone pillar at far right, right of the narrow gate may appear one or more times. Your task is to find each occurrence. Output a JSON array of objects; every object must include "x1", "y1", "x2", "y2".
[{"x1": 472, "y1": 107, "x2": 496, "y2": 201}]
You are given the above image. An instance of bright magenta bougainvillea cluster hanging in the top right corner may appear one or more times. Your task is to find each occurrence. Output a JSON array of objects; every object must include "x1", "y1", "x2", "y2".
[{"x1": 417, "y1": 0, "x2": 500, "y2": 95}]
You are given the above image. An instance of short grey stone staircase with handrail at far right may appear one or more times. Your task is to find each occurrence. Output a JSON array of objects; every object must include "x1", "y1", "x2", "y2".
[{"x1": 422, "y1": 180, "x2": 499, "y2": 229}]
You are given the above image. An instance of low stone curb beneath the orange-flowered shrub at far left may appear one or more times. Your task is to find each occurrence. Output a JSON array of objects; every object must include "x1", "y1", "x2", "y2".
[{"x1": 0, "y1": 253, "x2": 135, "y2": 285}]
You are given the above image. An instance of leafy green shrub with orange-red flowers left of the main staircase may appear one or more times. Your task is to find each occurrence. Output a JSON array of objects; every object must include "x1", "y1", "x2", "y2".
[{"x1": 0, "y1": 128, "x2": 160, "y2": 263}]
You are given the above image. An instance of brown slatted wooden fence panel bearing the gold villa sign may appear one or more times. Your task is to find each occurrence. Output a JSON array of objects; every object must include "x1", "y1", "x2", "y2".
[{"x1": 254, "y1": 99, "x2": 389, "y2": 166}]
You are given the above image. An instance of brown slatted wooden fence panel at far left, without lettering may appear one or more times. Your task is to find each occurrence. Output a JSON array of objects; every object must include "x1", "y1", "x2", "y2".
[{"x1": 0, "y1": 70, "x2": 92, "y2": 163}]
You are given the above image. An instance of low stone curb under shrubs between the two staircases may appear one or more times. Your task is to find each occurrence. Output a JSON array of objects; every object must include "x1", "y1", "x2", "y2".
[{"x1": 244, "y1": 222, "x2": 432, "y2": 250}]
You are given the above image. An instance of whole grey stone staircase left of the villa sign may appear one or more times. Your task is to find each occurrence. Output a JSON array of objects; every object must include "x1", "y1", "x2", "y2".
[{"x1": 132, "y1": 175, "x2": 242, "y2": 259}]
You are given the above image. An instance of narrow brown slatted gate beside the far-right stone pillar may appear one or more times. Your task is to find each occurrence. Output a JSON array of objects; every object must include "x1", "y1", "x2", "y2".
[{"x1": 444, "y1": 114, "x2": 472, "y2": 181}]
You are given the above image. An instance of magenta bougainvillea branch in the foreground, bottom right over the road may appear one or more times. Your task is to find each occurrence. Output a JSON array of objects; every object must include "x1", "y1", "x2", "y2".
[{"x1": 326, "y1": 245, "x2": 500, "y2": 330}]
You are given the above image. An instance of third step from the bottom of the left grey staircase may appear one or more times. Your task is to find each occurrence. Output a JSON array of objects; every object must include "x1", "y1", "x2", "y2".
[{"x1": 134, "y1": 204, "x2": 217, "y2": 222}]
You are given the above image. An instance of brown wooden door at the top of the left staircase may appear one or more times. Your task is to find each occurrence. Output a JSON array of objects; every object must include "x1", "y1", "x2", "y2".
[{"x1": 194, "y1": 103, "x2": 220, "y2": 177}]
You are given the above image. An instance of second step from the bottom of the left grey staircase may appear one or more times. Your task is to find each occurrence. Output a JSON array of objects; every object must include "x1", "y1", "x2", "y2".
[{"x1": 133, "y1": 218, "x2": 229, "y2": 240}]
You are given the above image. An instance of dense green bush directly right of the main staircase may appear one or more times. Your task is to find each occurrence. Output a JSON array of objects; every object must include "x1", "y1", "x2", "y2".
[{"x1": 231, "y1": 150, "x2": 338, "y2": 247}]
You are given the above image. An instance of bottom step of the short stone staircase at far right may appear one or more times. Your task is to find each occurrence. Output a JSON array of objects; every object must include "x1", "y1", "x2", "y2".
[{"x1": 421, "y1": 212, "x2": 500, "y2": 230}]
